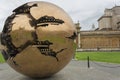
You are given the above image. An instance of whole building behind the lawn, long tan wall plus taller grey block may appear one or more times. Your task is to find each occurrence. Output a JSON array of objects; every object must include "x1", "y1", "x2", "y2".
[{"x1": 76, "y1": 6, "x2": 120, "y2": 50}]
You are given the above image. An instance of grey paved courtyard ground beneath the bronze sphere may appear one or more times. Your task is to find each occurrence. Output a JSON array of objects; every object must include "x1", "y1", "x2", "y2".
[{"x1": 0, "y1": 60, "x2": 120, "y2": 80}]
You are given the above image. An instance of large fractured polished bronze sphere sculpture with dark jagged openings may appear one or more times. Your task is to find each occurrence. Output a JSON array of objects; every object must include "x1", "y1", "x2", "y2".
[{"x1": 1, "y1": 2, "x2": 76, "y2": 78}]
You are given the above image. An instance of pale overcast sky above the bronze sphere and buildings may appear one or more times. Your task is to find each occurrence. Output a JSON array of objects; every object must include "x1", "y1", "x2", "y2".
[{"x1": 0, "y1": 0, "x2": 120, "y2": 31}]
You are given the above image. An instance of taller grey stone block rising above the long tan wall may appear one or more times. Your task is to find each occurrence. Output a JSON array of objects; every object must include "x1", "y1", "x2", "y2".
[{"x1": 98, "y1": 6, "x2": 120, "y2": 30}]
